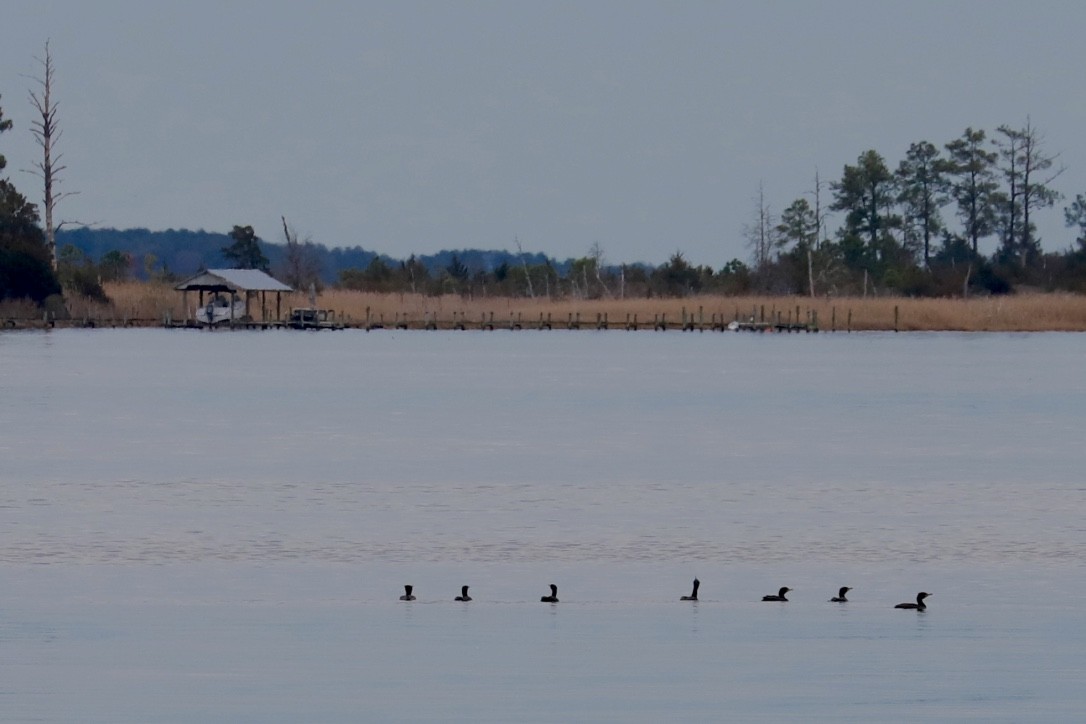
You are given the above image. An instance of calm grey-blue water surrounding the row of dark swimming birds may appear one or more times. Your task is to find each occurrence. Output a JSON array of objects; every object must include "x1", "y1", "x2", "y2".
[{"x1": 0, "y1": 330, "x2": 1086, "y2": 722}]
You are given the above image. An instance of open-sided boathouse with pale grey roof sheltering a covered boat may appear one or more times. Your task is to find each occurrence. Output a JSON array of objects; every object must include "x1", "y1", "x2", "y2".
[{"x1": 174, "y1": 269, "x2": 294, "y2": 325}]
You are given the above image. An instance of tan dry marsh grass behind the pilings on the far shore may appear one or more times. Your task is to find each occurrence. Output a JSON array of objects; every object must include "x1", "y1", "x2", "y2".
[{"x1": 12, "y1": 282, "x2": 1086, "y2": 331}]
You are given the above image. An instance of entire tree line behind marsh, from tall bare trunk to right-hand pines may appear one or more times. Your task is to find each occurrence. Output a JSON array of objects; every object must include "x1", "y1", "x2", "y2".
[{"x1": 6, "y1": 56, "x2": 1086, "y2": 305}]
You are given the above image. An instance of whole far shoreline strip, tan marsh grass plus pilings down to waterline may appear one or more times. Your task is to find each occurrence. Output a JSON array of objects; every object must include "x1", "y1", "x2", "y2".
[{"x1": 6, "y1": 282, "x2": 1086, "y2": 332}]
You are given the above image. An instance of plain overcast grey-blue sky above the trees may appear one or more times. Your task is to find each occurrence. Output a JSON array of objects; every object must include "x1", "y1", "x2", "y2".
[{"x1": 0, "y1": 0, "x2": 1086, "y2": 268}]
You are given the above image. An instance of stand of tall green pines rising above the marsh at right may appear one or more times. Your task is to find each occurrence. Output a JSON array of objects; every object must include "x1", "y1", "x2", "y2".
[{"x1": 744, "y1": 119, "x2": 1086, "y2": 296}]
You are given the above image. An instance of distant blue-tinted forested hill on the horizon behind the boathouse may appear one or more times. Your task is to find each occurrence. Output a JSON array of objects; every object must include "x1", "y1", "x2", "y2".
[{"x1": 56, "y1": 228, "x2": 570, "y2": 284}]
